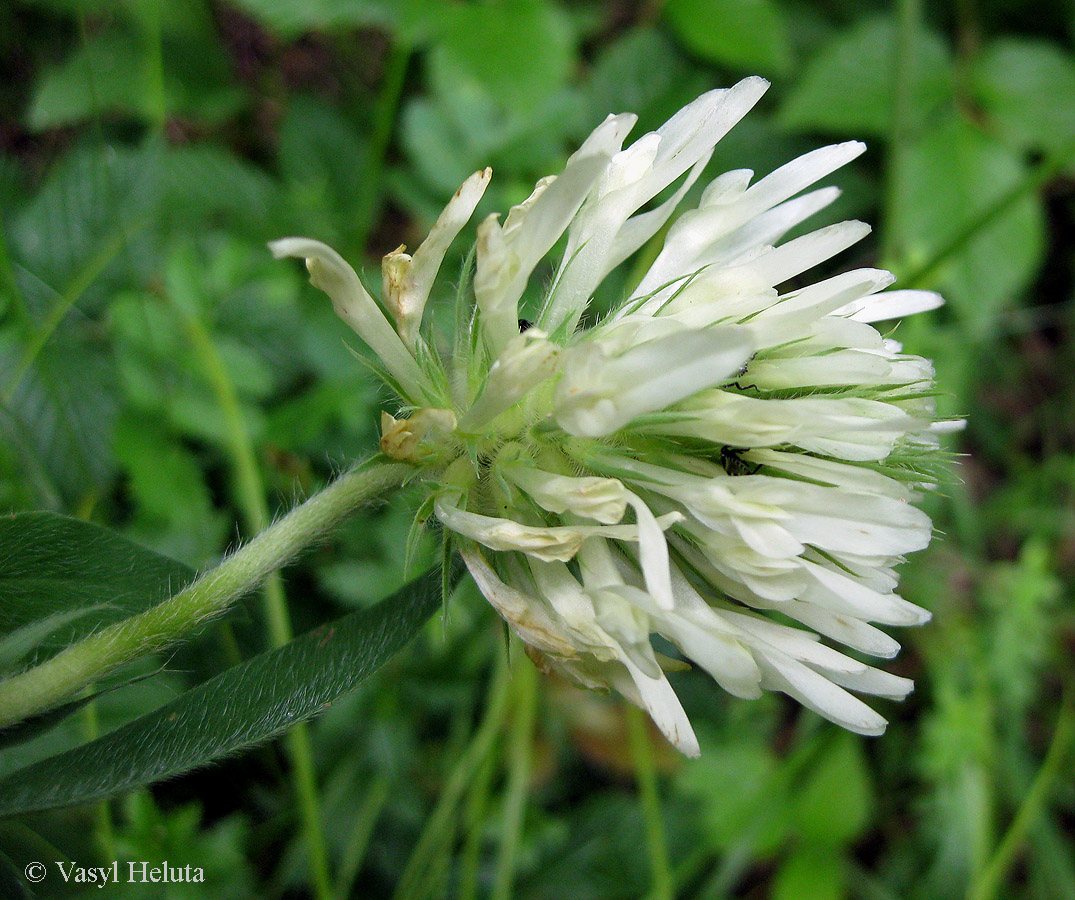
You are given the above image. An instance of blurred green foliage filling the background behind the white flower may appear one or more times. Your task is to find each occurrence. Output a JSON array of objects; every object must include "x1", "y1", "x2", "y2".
[{"x1": 0, "y1": 0, "x2": 1075, "y2": 900}]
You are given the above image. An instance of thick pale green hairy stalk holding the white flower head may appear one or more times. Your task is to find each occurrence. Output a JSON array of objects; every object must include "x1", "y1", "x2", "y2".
[{"x1": 0, "y1": 462, "x2": 414, "y2": 727}]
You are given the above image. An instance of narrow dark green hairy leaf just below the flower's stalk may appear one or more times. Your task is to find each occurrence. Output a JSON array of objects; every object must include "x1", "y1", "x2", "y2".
[{"x1": 0, "y1": 571, "x2": 449, "y2": 815}]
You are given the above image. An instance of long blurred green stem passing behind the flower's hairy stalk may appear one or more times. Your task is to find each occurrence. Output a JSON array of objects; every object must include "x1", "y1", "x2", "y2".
[{"x1": 176, "y1": 304, "x2": 333, "y2": 900}]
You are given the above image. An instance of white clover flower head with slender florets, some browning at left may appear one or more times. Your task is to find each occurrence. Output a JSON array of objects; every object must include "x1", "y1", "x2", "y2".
[{"x1": 272, "y1": 78, "x2": 954, "y2": 755}]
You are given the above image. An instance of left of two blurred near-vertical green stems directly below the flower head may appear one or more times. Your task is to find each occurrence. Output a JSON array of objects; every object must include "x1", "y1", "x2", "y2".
[{"x1": 491, "y1": 655, "x2": 538, "y2": 900}]
